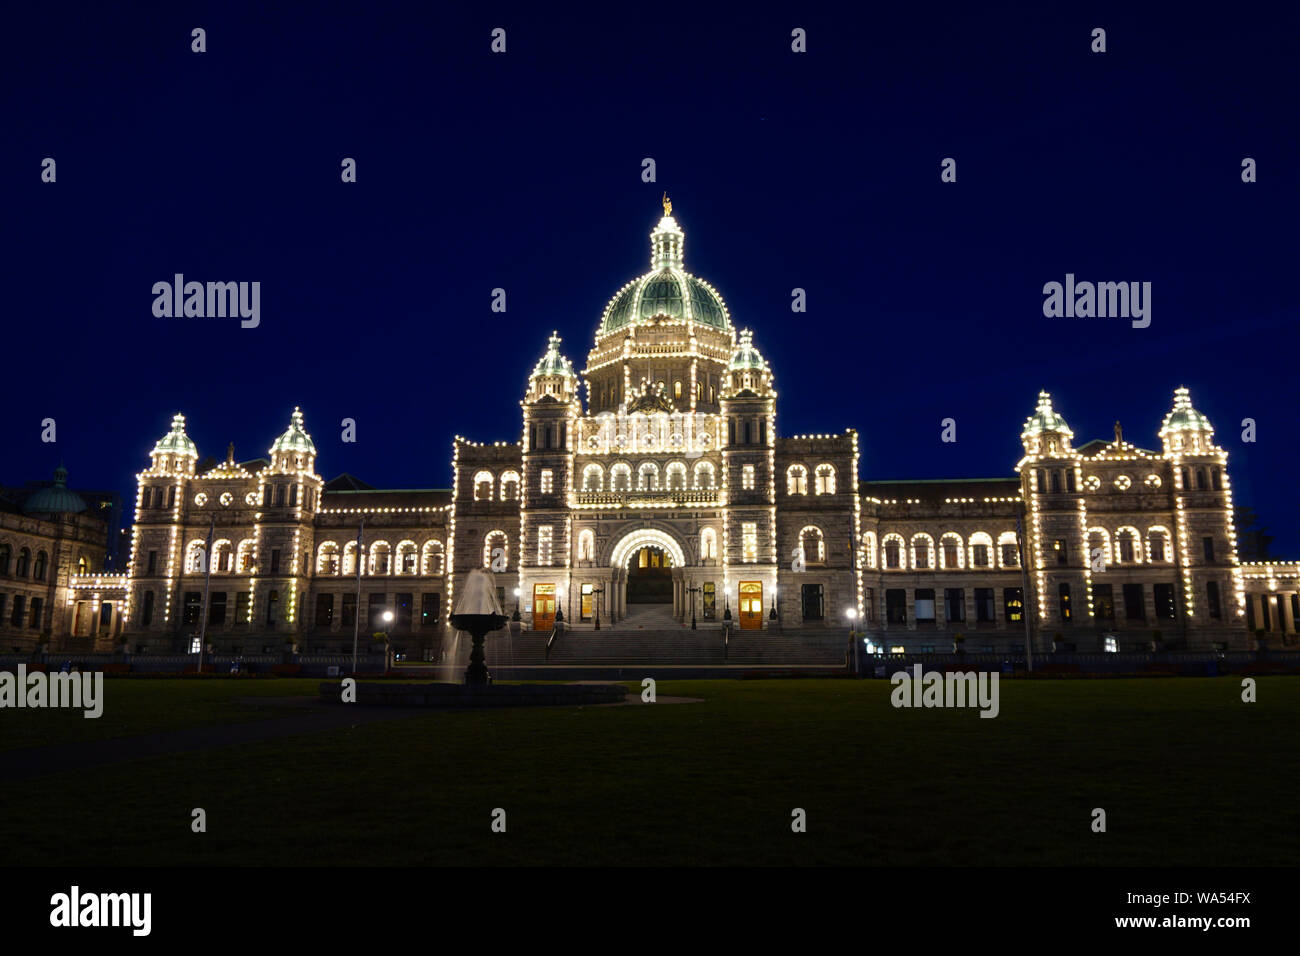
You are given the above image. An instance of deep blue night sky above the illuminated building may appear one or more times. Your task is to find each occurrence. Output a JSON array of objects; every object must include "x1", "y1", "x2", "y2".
[{"x1": 10, "y1": 3, "x2": 1300, "y2": 557}]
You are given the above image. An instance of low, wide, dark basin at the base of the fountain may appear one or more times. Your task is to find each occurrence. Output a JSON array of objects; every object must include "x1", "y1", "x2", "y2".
[{"x1": 320, "y1": 680, "x2": 628, "y2": 709}]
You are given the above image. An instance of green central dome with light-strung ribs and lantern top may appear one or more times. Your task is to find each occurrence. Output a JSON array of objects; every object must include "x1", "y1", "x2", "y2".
[{"x1": 597, "y1": 215, "x2": 731, "y2": 336}]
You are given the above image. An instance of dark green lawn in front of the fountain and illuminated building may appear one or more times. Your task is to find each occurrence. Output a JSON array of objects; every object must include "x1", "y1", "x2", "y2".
[{"x1": 0, "y1": 678, "x2": 1300, "y2": 866}]
